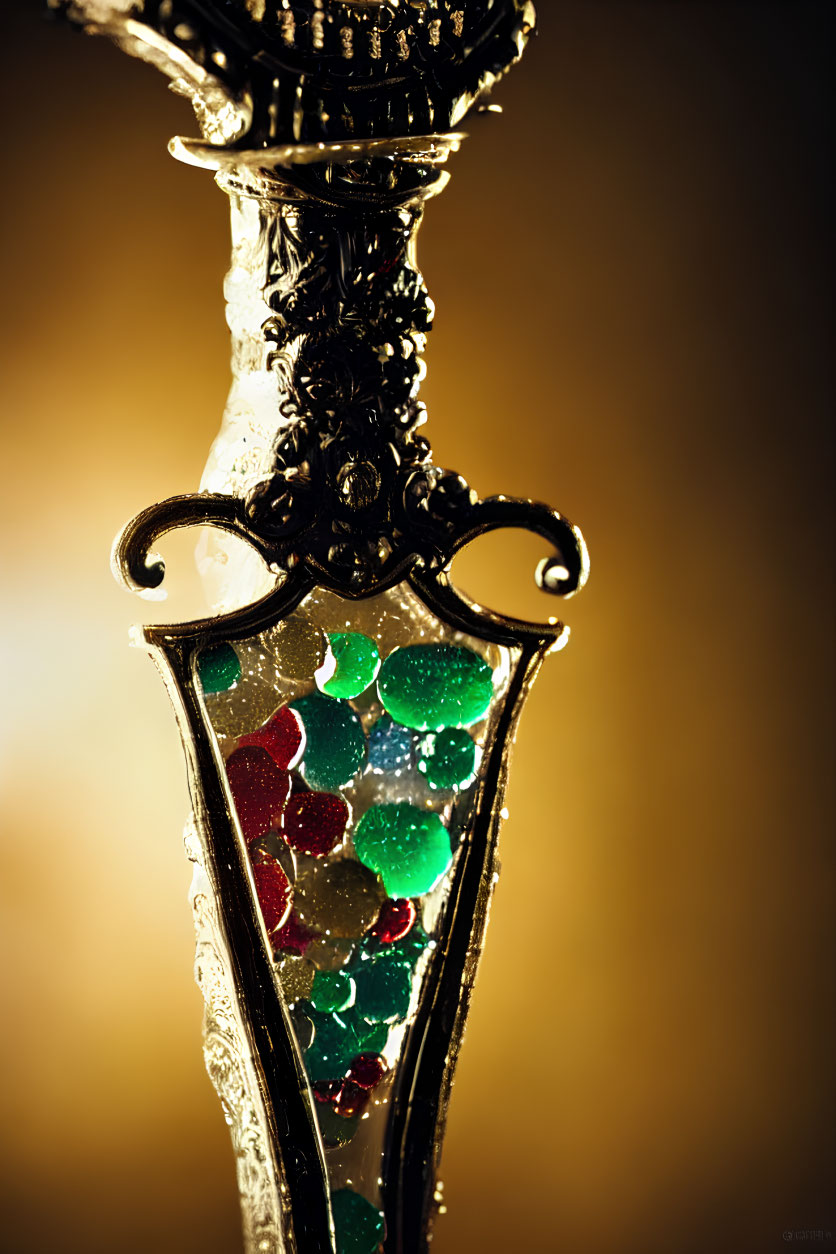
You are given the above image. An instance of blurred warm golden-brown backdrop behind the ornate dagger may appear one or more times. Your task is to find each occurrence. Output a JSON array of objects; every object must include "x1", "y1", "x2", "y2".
[{"x1": 0, "y1": 0, "x2": 836, "y2": 1254}]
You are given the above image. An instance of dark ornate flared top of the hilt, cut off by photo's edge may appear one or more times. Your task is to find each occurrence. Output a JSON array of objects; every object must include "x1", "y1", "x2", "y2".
[{"x1": 55, "y1": 0, "x2": 534, "y2": 149}]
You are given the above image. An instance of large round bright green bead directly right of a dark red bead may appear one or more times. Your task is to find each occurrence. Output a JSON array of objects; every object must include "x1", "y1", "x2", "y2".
[{"x1": 353, "y1": 801, "x2": 452, "y2": 897}]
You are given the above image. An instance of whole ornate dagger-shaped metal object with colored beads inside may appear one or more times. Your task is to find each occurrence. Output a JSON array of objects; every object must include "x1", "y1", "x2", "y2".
[{"x1": 54, "y1": 0, "x2": 587, "y2": 1254}]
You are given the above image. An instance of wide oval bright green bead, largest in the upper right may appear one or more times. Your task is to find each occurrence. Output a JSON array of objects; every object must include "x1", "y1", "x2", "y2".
[{"x1": 377, "y1": 645, "x2": 494, "y2": 731}]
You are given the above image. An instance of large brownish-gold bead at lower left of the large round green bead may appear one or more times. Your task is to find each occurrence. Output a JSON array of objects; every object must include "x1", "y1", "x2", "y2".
[{"x1": 296, "y1": 862, "x2": 386, "y2": 937}]
